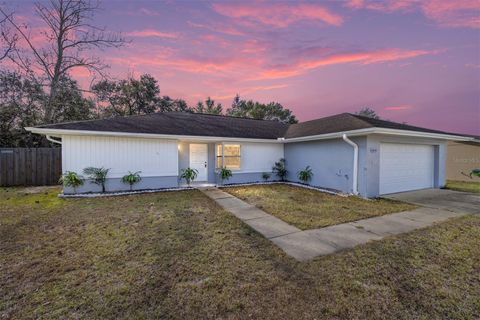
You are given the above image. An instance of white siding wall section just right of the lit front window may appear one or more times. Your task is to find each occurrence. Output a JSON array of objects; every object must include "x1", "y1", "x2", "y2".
[{"x1": 237, "y1": 142, "x2": 284, "y2": 173}]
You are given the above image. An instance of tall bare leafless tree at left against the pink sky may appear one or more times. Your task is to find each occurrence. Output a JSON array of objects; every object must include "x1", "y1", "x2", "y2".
[{"x1": 0, "y1": 0, "x2": 125, "y2": 122}]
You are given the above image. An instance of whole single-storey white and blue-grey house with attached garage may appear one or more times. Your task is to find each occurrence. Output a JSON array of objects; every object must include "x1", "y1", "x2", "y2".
[{"x1": 26, "y1": 112, "x2": 472, "y2": 197}]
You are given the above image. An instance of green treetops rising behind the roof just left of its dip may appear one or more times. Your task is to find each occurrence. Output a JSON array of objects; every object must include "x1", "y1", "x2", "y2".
[{"x1": 227, "y1": 95, "x2": 298, "y2": 124}]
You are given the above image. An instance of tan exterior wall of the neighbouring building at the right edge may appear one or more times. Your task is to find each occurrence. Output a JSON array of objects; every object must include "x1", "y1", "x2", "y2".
[{"x1": 447, "y1": 141, "x2": 480, "y2": 181}]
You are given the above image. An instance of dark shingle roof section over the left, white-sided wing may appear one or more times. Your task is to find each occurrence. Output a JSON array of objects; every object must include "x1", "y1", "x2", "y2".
[{"x1": 38, "y1": 112, "x2": 288, "y2": 139}]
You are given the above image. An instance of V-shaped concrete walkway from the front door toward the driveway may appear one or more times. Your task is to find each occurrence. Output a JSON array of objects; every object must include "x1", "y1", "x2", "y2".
[{"x1": 199, "y1": 188, "x2": 465, "y2": 261}]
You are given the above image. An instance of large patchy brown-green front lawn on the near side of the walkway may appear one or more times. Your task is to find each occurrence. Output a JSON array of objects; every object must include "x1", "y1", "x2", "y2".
[{"x1": 0, "y1": 189, "x2": 480, "y2": 319}]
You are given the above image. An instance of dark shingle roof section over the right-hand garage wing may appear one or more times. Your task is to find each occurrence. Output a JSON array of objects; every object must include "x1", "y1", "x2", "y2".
[{"x1": 285, "y1": 113, "x2": 454, "y2": 139}]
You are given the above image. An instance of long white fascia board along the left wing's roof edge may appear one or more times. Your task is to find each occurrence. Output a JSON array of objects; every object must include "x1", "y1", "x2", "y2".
[{"x1": 25, "y1": 127, "x2": 282, "y2": 143}]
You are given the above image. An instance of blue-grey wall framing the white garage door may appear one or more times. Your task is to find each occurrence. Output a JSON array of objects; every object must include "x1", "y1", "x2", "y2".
[{"x1": 368, "y1": 134, "x2": 446, "y2": 198}]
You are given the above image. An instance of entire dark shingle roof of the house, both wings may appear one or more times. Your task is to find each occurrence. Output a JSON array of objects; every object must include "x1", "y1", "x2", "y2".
[{"x1": 31, "y1": 112, "x2": 472, "y2": 140}]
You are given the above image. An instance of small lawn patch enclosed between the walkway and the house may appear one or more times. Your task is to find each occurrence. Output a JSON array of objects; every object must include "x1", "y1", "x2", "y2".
[{"x1": 222, "y1": 184, "x2": 416, "y2": 230}]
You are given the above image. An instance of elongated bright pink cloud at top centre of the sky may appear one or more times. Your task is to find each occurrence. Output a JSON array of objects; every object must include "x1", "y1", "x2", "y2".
[{"x1": 212, "y1": 2, "x2": 343, "y2": 28}]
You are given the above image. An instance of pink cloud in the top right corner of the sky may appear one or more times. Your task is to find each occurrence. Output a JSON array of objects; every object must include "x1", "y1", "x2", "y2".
[{"x1": 346, "y1": 0, "x2": 480, "y2": 28}]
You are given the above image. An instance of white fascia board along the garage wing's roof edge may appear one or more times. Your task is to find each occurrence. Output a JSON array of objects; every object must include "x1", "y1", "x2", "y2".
[{"x1": 284, "y1": 128, "x2": 473, "y2": 143}]
